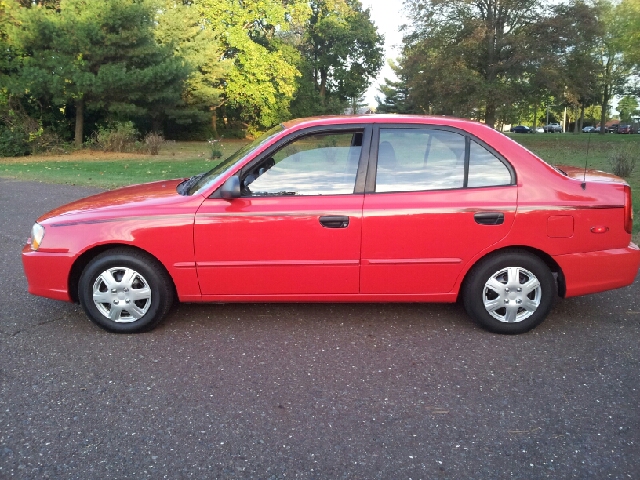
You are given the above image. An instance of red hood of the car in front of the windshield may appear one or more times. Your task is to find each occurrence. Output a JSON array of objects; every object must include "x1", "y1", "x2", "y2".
[{"x1": 38, "y1": 179, "x2": 184, "y2": 222}]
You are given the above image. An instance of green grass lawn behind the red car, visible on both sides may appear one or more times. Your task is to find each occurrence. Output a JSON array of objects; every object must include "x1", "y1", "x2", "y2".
[{"x1": 0, "y1": 134, "x2": 640, "y2": 241}]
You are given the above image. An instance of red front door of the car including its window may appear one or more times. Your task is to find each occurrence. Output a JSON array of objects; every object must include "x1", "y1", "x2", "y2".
[{"x1": 195, "y1": 128, "x2": 364, "y2": 299}]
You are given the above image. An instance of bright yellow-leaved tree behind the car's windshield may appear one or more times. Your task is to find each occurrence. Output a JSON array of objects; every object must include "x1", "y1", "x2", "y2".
[{"x1": 195, "y1": 0, "x2": 309, "y2": 129}]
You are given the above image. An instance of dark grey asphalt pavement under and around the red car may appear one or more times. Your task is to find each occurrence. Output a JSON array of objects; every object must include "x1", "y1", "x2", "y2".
[{"x1": 0, "y1": 179, "x2": 640, "y2": 480}]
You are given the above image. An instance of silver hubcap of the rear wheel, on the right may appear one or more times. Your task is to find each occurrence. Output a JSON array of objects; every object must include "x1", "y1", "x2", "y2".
[{"x1": 482, "y1": 267, "x2": 542, "y2": 323}]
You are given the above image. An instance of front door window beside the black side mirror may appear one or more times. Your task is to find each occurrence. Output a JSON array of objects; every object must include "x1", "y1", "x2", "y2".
[{"x1": 242, "y1": 131, "x2": 363, "y2": 197}]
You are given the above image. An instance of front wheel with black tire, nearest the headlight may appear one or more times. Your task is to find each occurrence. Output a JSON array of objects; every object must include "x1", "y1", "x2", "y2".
[{"x1": 78, "y1": 248, "x2": 175, "y2": 333}]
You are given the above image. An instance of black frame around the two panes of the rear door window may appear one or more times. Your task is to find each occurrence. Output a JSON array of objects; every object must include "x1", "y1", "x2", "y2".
[{"x1": 365, "y1": 123, "x2": 518, "y2": 195}]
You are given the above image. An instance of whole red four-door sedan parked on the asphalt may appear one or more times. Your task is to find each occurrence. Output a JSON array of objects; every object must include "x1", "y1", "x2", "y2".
[{"x1": 22, "y1": 115, "x2": 640, "y2": 333}]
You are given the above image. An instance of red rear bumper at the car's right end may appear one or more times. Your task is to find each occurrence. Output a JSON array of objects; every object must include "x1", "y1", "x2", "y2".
[{"x1": 553, "y1": 243, "x2": 640, "y2": 297}]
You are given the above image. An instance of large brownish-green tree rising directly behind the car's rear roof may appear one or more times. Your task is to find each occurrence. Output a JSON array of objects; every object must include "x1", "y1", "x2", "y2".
[{"x1": 403, "y1": 0, "x2": 549, "y2": 127}]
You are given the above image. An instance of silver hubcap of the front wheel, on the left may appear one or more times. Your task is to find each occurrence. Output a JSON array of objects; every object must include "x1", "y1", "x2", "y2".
[{"x1": 93, "y1": 267, "x2": 151, "y2": 323}]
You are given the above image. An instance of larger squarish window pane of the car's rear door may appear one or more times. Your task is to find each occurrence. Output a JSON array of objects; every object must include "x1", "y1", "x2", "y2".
[{"x1": 376, "y1": 128, "x2": 465, "y2": 192}]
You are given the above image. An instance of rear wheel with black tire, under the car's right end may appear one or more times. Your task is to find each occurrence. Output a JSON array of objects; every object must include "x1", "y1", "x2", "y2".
[{"x1": 462, "y1": 250, "x2": 558, "y2": 334}]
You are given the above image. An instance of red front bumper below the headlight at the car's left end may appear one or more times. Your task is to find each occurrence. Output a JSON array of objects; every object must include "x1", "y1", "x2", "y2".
[{"x1": 22, "y1": 245, "x2": 75, "y2": 302}]
